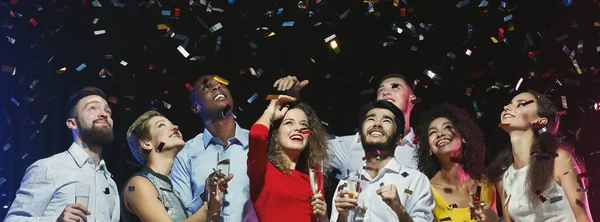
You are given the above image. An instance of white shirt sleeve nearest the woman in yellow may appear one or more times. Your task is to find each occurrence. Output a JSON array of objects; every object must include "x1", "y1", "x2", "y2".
[{"x1": 404, "y1": 174, "x2": 435, "y2": 222}]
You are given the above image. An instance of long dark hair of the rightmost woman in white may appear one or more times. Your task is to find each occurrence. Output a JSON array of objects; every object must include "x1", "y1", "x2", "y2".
[{"x1": 487, "y1": 90, "x2": 560, "y2": 206}]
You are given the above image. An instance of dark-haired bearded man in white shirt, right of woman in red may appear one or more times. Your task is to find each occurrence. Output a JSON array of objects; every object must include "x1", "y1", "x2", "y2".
[{"x1": 330, "y1": 100, "x2": 435, "y2": 222}]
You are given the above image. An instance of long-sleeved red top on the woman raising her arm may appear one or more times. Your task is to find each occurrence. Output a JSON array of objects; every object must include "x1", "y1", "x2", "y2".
[{"x1": 248, "y1": 124, "x2": 324, "y2": 222}]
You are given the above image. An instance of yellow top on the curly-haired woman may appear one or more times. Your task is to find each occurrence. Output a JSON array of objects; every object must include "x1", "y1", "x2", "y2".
[{"x1": 431, "y1": 180, "x2": 496, "y2": 222}]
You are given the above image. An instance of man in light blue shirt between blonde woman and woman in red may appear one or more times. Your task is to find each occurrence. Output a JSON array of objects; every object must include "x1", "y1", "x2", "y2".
[{"x1": 171, "y1": 75, "x2": 258, "y2": 222}]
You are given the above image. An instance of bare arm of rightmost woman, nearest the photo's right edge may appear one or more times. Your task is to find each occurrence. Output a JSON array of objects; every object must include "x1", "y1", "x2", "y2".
[{"x1": 554, "y1": 148, "x2": 593, "y2": 221}]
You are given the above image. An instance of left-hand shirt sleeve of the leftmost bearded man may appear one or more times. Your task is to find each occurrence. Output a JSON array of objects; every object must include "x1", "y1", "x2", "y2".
[{"x1": 4, "y1": 162, "x2": 58, "y2": 222}]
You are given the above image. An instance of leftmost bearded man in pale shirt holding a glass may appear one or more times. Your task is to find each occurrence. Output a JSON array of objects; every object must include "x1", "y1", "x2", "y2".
[{"x1": 4, "y1": 87, "x2": 120, "y2": 222}]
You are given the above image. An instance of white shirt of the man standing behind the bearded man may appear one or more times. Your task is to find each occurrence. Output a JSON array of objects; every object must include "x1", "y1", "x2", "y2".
[{"x1": 327, "y1": 128, "x2": 418, "y2": 175}]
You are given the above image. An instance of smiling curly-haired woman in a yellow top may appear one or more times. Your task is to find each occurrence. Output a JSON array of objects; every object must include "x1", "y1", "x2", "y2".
[{"x1": 417, "y1": 103, "x2": 496, "y2": 221}]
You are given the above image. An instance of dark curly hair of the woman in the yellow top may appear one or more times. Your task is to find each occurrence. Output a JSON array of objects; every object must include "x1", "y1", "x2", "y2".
[{"x1": 417, "y1": 103, "x2": 486, "y2": 180}]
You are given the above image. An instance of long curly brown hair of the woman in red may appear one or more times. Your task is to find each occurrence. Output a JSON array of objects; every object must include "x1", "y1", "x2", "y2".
[{"x1": 267, "y1": 102, "x2": 329, "y2": 175}]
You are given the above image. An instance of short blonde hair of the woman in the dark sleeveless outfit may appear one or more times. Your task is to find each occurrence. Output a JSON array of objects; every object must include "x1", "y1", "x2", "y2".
[{"x1": 127, "y1": 110, "x2": 163, "y2": 165}]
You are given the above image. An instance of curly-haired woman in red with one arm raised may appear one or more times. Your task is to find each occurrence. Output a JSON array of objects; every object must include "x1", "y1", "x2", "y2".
[{"x1": 248, "y1": 96, "x2": 329, "y2": 222}]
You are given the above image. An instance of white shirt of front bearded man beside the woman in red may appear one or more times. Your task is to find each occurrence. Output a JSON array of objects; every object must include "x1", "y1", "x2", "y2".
[{"x1": 330, "y1": 157, "x2": 435, "y2": 222}]
